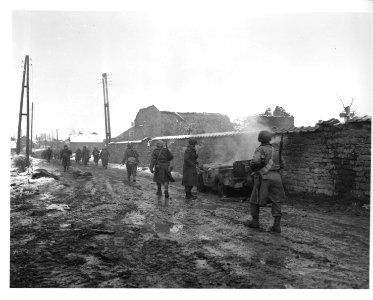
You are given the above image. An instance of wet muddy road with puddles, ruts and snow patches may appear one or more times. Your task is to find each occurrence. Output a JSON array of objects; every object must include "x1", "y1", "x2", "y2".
[{"x1": 10, "y1": 159, "x2": 369, "y2": 288}]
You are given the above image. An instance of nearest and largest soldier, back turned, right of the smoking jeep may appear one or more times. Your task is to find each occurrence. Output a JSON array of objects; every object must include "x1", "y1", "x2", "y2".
[{"x1": 247, "y1": 131, "x2": 285, "y2": 233}]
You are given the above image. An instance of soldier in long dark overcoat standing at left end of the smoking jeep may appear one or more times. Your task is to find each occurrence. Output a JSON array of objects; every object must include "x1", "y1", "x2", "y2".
[{"x1": 181, "y1": 139, "x2": 198, "y2": 200}]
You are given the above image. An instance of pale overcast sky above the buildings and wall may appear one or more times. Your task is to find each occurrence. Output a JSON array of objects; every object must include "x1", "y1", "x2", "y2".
[{"x1": 11, "y1": 10, "x2": 372, "y2": 138}]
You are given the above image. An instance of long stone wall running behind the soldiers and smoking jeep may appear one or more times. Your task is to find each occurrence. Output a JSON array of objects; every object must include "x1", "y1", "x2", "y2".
[{"x1": 109, "y1": 122, "x2": 371, "y2": 199}]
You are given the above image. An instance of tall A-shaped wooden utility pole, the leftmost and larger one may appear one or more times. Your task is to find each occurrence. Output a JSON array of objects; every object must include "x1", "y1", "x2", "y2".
[{"x1": 16, "y1": 55, "x2": 30, "y2": 161}]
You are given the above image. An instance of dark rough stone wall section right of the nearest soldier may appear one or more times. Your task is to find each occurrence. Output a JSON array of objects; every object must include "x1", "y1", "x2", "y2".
[{"x1": 282, "y1": 122, "x2": 371, "y2": 199}]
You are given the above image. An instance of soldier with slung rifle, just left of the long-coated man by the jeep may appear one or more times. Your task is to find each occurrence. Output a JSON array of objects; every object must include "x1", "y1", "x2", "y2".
[{"x1": 149, "y1": 141, "x2": 174, "y2": 198}]
